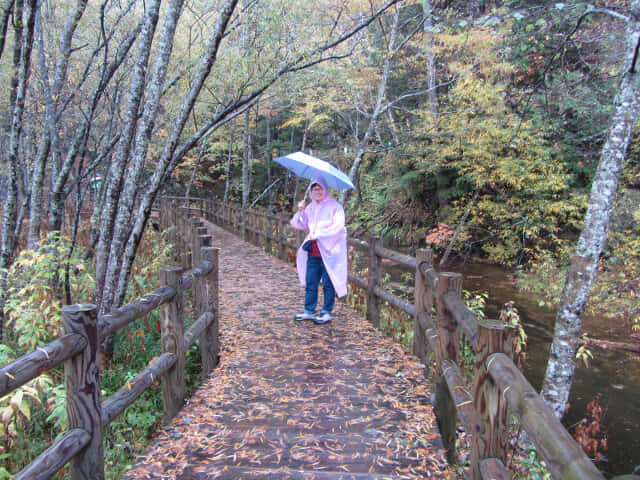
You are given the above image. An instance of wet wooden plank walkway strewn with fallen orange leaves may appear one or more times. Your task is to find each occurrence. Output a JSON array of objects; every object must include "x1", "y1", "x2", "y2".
[{"x1": 124, "y1": 224, "x2": 455, "y2": 480}]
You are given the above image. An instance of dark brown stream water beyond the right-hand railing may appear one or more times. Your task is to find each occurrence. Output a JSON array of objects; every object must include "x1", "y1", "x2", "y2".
[{"x1": 372, "y1": 255, "x2": 640, "y2": 477}]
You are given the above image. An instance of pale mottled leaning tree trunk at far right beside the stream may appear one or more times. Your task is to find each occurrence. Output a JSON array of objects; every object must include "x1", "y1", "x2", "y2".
[{"x1": 541, "y1": 0, "x2": 640, "y2": 418}]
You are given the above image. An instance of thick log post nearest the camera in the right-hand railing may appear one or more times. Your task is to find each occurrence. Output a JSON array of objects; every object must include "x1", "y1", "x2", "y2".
[{"x1": 471, "y1": 319, "x2": 514, "y2": 480}]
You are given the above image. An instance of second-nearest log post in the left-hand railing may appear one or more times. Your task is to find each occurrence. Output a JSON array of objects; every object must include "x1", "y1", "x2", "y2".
[{"x1": 160, "y1": 267, "x2": 185, "y2": 424}]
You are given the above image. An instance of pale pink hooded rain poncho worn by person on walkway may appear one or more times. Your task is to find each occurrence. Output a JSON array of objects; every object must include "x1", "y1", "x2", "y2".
[{"x1": 291, "y1": 175, "x2": 347, "y2": 297}]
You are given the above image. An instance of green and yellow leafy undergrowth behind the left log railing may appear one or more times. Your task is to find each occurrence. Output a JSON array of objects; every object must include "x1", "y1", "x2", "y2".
[{"x1": 0, "y1": 228, "x2": 200, "y2": 480}]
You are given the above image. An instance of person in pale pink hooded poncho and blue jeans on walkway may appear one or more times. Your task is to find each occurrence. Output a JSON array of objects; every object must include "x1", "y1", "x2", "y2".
[{"x1": 291, "y1": 175, "x2": 347, "y2": 325}]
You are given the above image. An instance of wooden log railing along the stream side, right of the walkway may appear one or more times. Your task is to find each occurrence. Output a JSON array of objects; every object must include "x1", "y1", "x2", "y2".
[{"x1": 195, "y1": 199, "x2": 640, "y2": 480}]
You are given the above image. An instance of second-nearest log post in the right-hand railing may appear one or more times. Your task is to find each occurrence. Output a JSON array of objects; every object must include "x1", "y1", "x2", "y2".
[{"x1": 434, "y1": 272, "x2": 462, "y2": 465}]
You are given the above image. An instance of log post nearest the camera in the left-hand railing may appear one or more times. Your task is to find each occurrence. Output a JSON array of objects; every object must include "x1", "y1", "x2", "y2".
[{"x1": 62, "y1": 305, "x2": 104, "y2": 480}]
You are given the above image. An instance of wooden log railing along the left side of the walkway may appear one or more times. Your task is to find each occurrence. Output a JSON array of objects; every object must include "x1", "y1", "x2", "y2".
[{"x1": 0, "y1": 203, "x2": 218, "y2": 480}]
